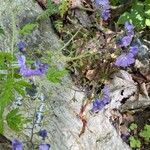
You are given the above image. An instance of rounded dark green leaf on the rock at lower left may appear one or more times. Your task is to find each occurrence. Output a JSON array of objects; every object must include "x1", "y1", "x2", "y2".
[{"x1": 6, "y1": 108, "x2": 25, "y2": 132}]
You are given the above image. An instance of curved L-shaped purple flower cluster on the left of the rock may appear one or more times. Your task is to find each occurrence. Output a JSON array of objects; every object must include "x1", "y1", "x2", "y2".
[{"x1": 17, "y1": 55, "x2": 48, "y2": 77}]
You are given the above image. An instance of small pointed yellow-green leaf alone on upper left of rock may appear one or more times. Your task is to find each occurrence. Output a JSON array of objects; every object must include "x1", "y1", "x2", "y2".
[{"x1": 19, "y1": 23, "x2": 38, "y2": 35}]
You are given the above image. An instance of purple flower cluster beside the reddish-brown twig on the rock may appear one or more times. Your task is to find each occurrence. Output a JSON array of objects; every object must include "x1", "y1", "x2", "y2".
[{"x1": 92, "y1": 85, "x2": 110, "y2": 112}]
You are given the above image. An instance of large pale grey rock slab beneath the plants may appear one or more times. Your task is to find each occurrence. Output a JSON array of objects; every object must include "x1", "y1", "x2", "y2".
[{"x1": 0, "y1": 0, "x2": 130, "y2": 150}]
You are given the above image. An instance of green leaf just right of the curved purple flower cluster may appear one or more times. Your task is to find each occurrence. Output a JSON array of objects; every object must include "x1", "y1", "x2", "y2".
[{"x1": 46, "y1": 68, "x2": 67, "y2": 83}]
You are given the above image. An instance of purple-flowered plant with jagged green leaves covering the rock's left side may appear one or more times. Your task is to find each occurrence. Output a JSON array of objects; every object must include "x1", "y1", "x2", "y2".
[{"x1": 0, "y1": 11, "x2": 66, "y2": 150}]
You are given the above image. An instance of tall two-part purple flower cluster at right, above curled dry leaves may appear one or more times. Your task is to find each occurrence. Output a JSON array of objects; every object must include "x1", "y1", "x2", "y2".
[{"x1": 115, "y1": 22, "x2": 139, "y2": 67}]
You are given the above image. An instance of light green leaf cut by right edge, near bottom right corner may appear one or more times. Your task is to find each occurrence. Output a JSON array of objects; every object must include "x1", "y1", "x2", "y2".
[{"x1": 139, "y1": 124, "x2": 150, "y2": 141}]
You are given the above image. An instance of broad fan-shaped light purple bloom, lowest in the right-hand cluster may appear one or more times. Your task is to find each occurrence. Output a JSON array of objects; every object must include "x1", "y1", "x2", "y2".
[{"x1": 115, "y1": 53, "x2": 135, "y2": 67}]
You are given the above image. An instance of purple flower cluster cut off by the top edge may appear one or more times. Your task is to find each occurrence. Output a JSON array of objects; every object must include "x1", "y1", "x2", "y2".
[{"x1": 95, "y1": 0, "x2": 110, "y2": 21}]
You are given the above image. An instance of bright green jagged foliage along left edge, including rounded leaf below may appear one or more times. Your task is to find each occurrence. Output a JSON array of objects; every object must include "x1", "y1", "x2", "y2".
[{"x1": 0, "y1": 51, "x2": 30, "y2": 133}]
